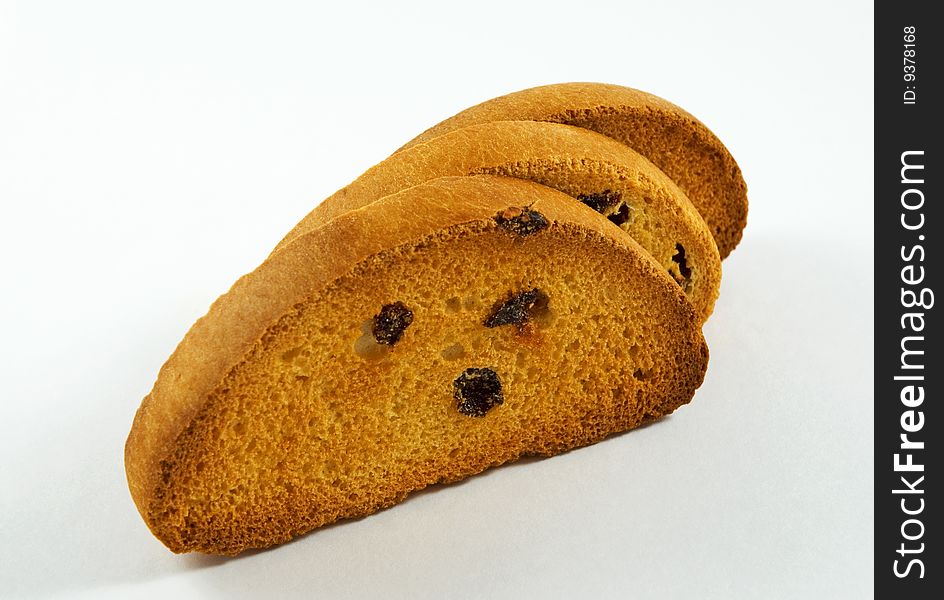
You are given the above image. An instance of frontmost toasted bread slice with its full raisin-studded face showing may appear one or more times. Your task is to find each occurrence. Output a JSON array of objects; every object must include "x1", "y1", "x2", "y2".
[{"x1": 125, "y1": 176, "x2": 708, "y2": 554}]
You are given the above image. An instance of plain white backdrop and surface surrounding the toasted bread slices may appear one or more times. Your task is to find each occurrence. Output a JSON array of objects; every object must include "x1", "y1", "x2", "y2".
[{"x1": 0, "y1": 0, "x2": 873, "y2": 599}]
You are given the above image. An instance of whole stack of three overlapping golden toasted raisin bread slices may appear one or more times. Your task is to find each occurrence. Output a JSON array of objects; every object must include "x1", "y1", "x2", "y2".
[{"x1": 125, "y1": 84, "x2": 747, "y2": 554}]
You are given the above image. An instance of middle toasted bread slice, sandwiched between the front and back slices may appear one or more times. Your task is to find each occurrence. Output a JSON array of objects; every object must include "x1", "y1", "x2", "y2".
[{"x1": 278, "y1": 121, "x2": 721, "y2": 321}]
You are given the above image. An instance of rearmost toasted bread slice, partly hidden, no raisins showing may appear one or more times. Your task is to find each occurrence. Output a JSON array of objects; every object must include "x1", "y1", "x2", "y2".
[{"x1": 404, "y1": 83, "x2": 747, "y2": 259}]
